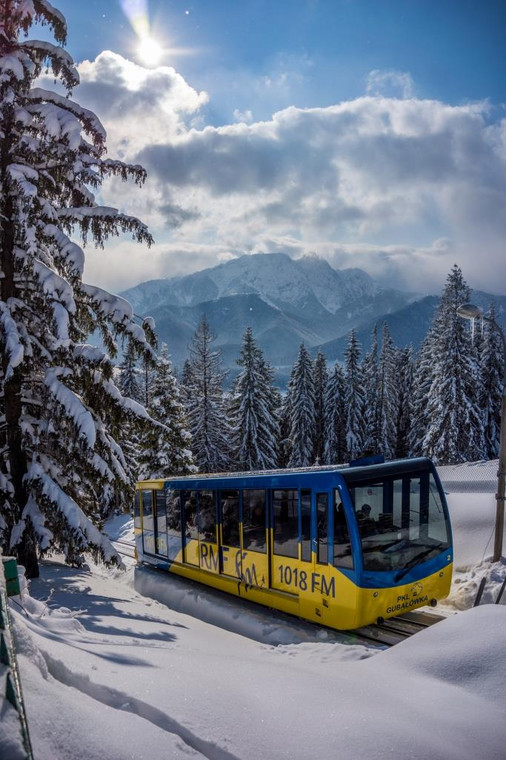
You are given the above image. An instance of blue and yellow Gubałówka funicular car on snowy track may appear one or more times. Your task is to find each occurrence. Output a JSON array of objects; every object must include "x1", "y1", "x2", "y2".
[{"x1": 135, "y1": 458, "x2": 453, "y2": 630}]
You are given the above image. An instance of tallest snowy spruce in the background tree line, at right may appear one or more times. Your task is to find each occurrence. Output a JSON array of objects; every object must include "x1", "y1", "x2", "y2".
[{"x1": 423, "y1": 265, "x2": 485, "y2": 464}]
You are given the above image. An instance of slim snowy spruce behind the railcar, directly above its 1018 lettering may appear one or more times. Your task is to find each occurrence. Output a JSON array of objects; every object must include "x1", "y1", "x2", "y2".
[{"x1": 288, "y1": 343, "x2": 316, "y2": 467}]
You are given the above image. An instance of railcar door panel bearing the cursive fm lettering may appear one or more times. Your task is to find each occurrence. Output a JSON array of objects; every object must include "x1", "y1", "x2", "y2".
[{"x1": 241, "y1": 488, "x2": 269, "y2": 588}]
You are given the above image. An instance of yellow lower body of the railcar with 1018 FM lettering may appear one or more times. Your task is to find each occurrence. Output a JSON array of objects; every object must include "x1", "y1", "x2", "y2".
[{"x1": 139, "y1": 535, "x2": 452, "y2": 630}]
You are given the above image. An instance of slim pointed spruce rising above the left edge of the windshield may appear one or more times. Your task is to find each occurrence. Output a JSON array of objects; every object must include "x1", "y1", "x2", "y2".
[{"x1": 344, "y1": 330, "x2": 365, "y2": 459}]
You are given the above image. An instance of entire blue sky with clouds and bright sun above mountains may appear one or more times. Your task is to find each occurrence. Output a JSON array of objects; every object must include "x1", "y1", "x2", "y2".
[{"x1": 34, "y1": 0, "x2": 506, "y2": 294}]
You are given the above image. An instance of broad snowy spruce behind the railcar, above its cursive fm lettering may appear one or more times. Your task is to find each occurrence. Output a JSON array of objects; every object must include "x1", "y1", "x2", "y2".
[{"x1": 230, "y1": 327, "x2": 279, "y2": 470}]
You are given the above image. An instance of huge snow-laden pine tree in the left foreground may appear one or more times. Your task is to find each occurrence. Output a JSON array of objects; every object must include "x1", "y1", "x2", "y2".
[{"x1": 0, "y1": 0, "x2": 155, "y2": 577}]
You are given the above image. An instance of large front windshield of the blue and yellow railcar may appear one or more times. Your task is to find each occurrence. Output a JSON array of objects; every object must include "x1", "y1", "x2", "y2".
[{"x1": 350, "y1": 472, "x2": 450, "y2": 580}]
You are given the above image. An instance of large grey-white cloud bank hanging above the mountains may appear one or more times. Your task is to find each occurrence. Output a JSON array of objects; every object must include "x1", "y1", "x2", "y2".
[{"x1": 54, "y1": 52, "x2": 506, "y2": 292}]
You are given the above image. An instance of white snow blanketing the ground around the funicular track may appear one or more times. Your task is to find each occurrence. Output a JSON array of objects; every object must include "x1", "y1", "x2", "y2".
[{"x1": 0, "y1": 465, "x2": 506, "y2": 760}]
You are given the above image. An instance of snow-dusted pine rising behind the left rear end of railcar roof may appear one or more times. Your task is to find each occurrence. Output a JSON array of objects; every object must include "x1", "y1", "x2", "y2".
[{"x1": 139, "y1": 343, "x2": 195, "y2": 479}]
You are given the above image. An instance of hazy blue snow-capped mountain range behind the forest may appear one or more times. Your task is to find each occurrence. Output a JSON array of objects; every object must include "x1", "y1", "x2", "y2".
[{"x1": 121, "y1": 253, "x2": 506, "y2": 386}]
